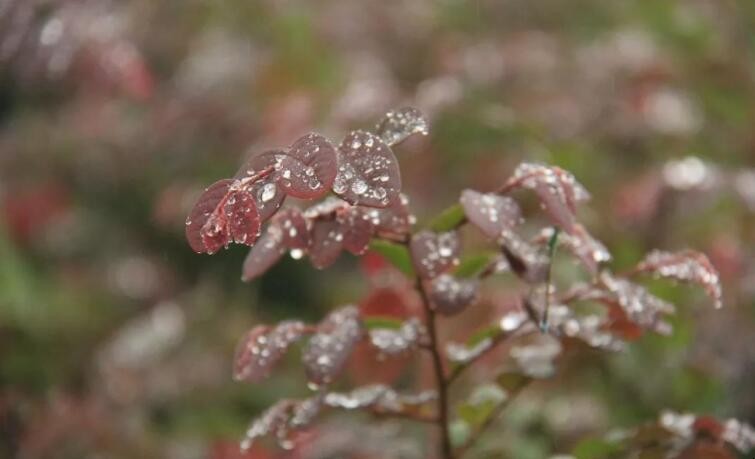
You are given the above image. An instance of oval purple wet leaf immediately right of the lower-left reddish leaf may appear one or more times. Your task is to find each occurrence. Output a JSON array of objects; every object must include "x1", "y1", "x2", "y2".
[{"x1": 302, "y1": 306, "x2": 364, "y2": 385}]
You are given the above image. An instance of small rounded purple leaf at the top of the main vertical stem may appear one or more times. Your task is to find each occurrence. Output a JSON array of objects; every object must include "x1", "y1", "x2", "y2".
[{"x1": 409, "y1": 230, "x2": 459, "y2": 279}]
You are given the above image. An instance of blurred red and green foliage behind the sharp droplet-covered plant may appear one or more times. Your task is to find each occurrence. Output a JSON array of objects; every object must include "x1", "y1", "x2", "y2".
[{"x1": 0, "y1": 0, "x2": 755, "y2": 459}]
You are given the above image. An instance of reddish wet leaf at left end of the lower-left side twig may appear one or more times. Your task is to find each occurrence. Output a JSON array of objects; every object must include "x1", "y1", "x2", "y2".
[{"x1": 233, "y1": 321, "x2": 306, "y2": 382}]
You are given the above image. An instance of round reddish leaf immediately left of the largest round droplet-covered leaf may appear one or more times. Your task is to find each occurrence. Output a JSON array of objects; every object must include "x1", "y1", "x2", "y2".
[{"x1": 276, "y1": 133, "x2": 337, "y2": 199}]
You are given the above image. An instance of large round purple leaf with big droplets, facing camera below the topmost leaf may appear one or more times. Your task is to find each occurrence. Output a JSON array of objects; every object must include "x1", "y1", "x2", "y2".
[{"x1": 333, "y1": 131, "x2": 401, "y2": 207}]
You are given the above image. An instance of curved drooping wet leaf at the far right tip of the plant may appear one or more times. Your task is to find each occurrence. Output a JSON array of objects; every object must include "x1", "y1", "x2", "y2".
[{"x1": 636, "y1": 250, "x2": 723, "y2": 308}]
